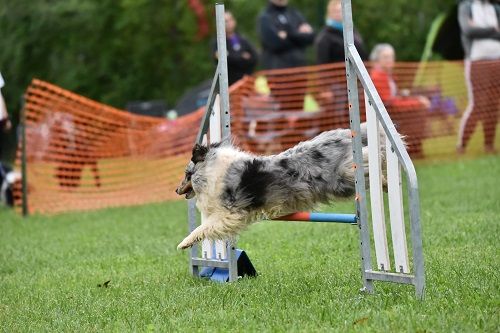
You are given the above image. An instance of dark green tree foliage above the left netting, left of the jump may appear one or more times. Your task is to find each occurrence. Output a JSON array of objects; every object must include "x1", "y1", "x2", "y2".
[{"x1": 0, "y1": 0, "x2": 213, "y2": 115}]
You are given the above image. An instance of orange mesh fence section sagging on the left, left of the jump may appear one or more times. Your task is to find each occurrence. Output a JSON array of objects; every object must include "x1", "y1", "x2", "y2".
[{"x1": 15, "y1": 80, "x2": 201, "y2": 213}]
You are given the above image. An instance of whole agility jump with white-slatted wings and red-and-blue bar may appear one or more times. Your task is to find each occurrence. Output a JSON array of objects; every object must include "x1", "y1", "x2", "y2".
[{"x1": 178, "y1": 0, "x2": 425, "y2": 298}]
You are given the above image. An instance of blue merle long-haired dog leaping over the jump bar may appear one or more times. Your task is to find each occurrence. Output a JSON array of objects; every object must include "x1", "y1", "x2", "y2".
[{"x1": 176, "y1": 124, "x2": 385, "y2": 249}]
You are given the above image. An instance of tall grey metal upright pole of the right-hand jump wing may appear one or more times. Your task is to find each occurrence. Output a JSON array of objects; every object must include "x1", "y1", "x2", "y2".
[{"x1": 342, "y1": 0, "x2": 373, "y2": 292}]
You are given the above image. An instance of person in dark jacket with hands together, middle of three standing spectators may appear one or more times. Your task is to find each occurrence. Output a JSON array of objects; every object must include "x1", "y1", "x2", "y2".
[{"x1": 258, "y1": 0, "x2": 314, "y2": 69}]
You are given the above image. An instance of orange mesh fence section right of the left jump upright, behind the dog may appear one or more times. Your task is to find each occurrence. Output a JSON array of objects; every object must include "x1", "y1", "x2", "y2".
[{"x1": 231, "y1": 61, "x2": 500, "y2": 159}]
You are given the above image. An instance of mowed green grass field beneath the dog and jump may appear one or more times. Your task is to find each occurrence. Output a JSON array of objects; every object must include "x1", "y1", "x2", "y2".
[{"x1": 0, "y1": 156, "x2": 500, "y2": 332}]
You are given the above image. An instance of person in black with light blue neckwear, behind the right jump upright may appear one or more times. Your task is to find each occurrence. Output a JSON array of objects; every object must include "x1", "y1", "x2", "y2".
[{"x1": 314, "y1": 0, "x2": 368, "y2": 65}]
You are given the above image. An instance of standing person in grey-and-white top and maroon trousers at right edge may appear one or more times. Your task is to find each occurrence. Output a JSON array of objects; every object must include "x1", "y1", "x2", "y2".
[{"x1": 457, "y1": 0, "x2": 500, "y2": 154}]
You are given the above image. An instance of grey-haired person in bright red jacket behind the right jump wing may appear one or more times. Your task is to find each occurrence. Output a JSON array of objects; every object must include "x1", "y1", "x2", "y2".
[{"x1": 370, "y1": 44, "x2": 430, "y2": 158}]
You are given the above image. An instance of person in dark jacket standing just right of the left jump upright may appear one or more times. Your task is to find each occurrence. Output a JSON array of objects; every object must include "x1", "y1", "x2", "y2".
[{"x1": 214, "y1": 11, "x2": 257, "y2": 85}]
